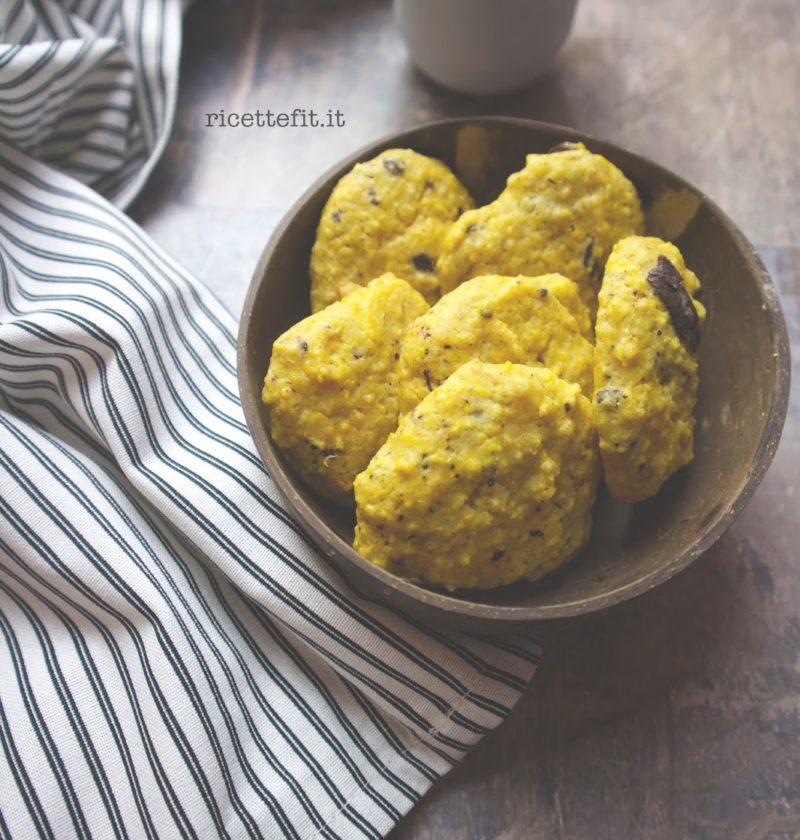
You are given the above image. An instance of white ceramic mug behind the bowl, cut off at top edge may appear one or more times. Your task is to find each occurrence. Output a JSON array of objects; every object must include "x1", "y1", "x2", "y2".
[{"x1": 394, "y1": 0, "x2": 577, "y2": 94}]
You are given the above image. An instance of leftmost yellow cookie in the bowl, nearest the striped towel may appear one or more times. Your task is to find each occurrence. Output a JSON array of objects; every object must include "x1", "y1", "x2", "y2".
[{"x1": 261, "y1": 274, "x2": 428, "y2": 503}]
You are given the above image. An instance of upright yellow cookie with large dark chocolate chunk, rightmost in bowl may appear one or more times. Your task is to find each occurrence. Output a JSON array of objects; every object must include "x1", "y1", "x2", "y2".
[{"x1": 594, "y1": 236, "x2": 705, "y2": 502}]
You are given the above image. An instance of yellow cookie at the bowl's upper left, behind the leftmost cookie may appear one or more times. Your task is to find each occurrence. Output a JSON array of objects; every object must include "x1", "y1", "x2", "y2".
[{"x1": 310, "y1": 149, "x2": 473, "y2": 312}]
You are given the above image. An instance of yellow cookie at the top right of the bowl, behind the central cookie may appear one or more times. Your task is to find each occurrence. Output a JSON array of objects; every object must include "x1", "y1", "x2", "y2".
[{"x1": 437, "y1": 143, "x2": 644, "y2": 315}]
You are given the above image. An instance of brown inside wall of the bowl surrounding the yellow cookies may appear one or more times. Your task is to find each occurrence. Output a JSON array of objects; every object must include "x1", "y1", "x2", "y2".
[{"x1": 239, "y1": 118, "x2": 788, "y2": 620}]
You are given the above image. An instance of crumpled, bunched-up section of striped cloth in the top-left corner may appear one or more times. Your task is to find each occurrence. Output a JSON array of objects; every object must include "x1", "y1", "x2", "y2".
[{"x1": 0, "y1": 0, "x2": 181, "y2": 207}]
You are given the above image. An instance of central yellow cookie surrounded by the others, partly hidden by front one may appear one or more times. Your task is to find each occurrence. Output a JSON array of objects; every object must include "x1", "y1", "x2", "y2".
[{"x1": 398, "y1": 274, "x2": 593, "y2": 412}]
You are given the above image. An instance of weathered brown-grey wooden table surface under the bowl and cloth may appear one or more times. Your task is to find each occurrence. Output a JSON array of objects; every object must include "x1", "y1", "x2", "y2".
[{"x1": 132, "y1": 0, "x2": 800, "y2": 840}]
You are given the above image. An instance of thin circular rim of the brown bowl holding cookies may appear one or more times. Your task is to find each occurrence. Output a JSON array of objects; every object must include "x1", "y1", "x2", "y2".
[{"x1": 236, "y1": 116, "x2": 791, "y2": 622}]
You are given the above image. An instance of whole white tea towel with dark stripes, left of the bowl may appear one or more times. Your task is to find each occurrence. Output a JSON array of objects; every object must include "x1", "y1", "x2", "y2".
[{"x1": 0, "y1": 0, "x2": 538, "y2": 838}]
